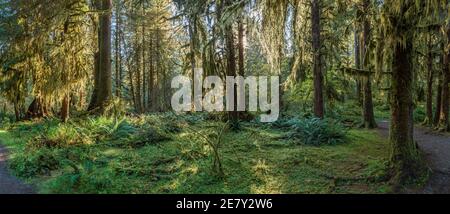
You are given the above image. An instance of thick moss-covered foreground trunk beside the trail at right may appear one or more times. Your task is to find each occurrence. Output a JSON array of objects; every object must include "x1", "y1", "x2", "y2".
[{"x1": 390, "y1": 38, "x2": 421, "y2": 183}]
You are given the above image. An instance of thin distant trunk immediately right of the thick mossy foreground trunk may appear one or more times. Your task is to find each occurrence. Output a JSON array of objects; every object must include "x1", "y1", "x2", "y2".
[{"x1": 423, "y1": 35, "x2": 434, "y2": 126}]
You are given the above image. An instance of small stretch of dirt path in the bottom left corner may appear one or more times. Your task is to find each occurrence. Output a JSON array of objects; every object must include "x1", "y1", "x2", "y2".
[{"x1": 0, "y1": 145, "x2": 34, "y2": 194}]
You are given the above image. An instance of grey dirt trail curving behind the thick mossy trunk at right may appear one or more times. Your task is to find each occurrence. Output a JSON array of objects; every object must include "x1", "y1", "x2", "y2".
[{"x1": 378, "y1": 121, "x2": 450, "y2": 194}]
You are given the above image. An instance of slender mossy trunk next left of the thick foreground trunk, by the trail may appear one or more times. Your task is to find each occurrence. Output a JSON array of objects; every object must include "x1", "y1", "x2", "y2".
[{"x1": 361, "y1": 0, "x2": 377, "y2": 129}]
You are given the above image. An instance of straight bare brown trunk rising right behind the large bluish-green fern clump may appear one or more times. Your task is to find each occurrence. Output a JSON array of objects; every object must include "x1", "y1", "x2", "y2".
[{"x1": 311, "y1": 0, "x2": 324, "y2": 118}]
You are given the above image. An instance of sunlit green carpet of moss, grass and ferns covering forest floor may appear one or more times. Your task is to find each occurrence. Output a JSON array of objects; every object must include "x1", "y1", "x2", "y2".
[{"x1": 0, "y1": 113, "x2": 391, "y2": 193}]
